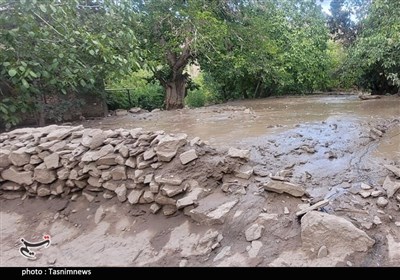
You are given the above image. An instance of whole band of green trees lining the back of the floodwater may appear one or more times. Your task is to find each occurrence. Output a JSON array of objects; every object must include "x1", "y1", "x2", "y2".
[{"x1": 0, "y1": 0, "x2": 400, "y2": 129}]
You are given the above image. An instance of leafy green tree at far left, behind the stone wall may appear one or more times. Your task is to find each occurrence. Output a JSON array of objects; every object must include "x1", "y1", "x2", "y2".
[{"x1": 0, "y1": 0, "x2": 139, "y2": 125}]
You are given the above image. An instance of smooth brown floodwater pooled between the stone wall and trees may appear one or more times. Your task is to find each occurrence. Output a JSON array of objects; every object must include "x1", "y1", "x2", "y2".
[{"x1": 86, "y1": 95, "x2": 400, "y2": 157}]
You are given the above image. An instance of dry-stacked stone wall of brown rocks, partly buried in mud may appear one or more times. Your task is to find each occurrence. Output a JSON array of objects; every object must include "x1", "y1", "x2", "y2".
[{"x1": 0, "y1": 125, "x2": 250, "y2": 215}]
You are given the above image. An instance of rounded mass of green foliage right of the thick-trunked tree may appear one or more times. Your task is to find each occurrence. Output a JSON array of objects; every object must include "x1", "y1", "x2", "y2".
[{"x1": 200, "y1": 0, "x2": 329, "y2": 100}]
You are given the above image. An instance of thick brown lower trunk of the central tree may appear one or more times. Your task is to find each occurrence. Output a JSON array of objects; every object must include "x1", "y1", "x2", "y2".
[{"x1": 165, "y1": 73, "x2": 186, "y2": 110}]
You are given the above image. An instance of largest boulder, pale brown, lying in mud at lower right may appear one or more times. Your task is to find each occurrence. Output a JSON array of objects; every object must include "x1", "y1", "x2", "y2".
[{"x1": 301, "y1": 211, "x2": 375, "y2": 255}]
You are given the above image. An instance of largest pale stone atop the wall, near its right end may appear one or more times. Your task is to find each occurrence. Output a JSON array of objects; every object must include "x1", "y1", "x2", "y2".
[{"x1": 155, "y1": 133, "x2": 187, "y2": 162}]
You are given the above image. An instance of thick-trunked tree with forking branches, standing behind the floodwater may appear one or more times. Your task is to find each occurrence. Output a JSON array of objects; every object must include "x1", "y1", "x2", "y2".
[{"x1": 136, "y1": 0, "x2": 227, "y2": 110}]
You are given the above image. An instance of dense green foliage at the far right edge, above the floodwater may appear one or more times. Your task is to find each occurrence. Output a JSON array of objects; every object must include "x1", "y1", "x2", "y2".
[{"x1": 344, "y1": 0, "x2": 400, "y2": 94}]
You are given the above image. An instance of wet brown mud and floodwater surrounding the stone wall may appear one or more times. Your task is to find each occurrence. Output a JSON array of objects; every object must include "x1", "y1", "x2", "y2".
[{"x1": 0, "y1": 95, "x2": 400, "y2": 267}]
